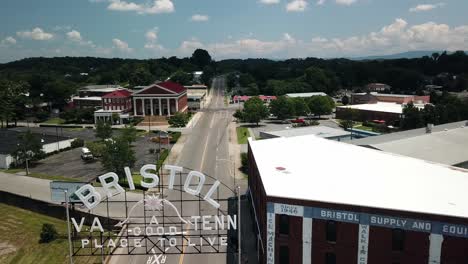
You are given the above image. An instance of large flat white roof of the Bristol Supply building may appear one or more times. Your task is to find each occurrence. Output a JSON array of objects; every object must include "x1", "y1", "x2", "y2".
[{"x1": 249, "y1": 136, "x2": 468, "y2": 218}]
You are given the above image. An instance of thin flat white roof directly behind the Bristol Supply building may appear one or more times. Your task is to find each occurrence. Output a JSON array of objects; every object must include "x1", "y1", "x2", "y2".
[{"x1": 262, "y1": 126, "x2": 350, "y2": 138}]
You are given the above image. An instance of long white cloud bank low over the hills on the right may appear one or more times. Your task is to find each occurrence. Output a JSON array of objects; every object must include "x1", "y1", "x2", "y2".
[{"x1": 177, "y1": 18, "x2": 468, "y2": 59}]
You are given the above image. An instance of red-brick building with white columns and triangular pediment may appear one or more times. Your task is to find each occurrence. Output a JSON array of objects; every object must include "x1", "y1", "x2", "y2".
[{"x1": 133, "y1": 82, "x2": 188, "y2": 116}]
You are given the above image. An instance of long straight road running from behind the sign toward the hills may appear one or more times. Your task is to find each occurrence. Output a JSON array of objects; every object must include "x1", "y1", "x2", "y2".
[{"x1": 111, "y1": 78, "x2": 239, "y2": 264}]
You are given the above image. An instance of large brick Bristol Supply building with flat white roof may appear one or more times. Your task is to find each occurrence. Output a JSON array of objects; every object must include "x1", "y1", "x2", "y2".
[{"x1": 248, "y1": 136, "x2": 468, "y2": 264}]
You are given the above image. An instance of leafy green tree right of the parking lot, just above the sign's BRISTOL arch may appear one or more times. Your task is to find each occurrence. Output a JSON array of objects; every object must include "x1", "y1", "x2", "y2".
[{"x1": 102, "y1": 136, "x2": 136, "y2": 178}]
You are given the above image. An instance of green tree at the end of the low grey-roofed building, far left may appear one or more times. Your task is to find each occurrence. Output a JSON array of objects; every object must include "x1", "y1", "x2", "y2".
[{"x1": 11, "y1": 130, "x2": 45, "y2": 171}]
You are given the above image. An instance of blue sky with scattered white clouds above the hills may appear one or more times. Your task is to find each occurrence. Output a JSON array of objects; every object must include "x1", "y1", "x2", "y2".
[{"x1": 0, "y1": 0, "x2": 468, "y2": 62}]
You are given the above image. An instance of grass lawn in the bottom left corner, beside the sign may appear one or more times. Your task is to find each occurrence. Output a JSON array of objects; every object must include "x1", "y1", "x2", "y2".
[{"x1": 0, "y1": 203, "x2": 99, "y2": 264}]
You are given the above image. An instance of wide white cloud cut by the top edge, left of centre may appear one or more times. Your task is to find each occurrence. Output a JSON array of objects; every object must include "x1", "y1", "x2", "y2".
[{"x1": 107, "y1": 0, "x2": 175, "y2": 14}]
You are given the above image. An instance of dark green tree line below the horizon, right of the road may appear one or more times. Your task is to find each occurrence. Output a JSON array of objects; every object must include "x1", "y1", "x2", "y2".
[{"x1": 222, "y1": 51, "x2": 468, "y2": 95}]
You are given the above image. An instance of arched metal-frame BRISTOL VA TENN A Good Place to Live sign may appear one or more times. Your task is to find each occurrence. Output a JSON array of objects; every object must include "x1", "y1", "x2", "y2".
[{"x1": 59, "y1": 165, "x2": 241, "y2": 263}]
